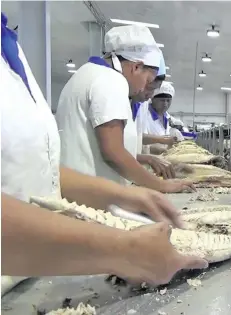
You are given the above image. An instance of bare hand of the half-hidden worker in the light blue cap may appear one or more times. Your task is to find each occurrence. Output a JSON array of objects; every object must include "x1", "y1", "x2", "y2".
[{"x1": 148, "y1": 156, "x2": 175, "y2": 179}]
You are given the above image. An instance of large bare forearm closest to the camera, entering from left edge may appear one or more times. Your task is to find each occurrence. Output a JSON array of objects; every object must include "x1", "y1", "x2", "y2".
[{"x1": 2, "y1": 194, "x2": 129, "y2": 276}]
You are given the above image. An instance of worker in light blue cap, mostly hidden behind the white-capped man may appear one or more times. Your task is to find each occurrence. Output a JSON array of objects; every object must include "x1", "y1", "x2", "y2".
[{"x1": 131, "y1": 52, "x2": 175, "y2": 179}]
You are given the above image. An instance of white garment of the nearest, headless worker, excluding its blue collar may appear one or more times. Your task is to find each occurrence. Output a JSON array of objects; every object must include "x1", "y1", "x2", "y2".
[{"x1": 1, "y1": 44, "x2": 60, "y2": 295}]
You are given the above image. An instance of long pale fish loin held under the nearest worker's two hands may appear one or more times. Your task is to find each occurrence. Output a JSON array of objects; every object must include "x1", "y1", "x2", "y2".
[{"x1": 31, "y1": 197, "x2": 231, "y2": 263}]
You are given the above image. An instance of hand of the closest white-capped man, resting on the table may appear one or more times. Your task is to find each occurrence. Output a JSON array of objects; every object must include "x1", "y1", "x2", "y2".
[{"x1": 161, "y1": 179, "x2": 196, "y2": 193}]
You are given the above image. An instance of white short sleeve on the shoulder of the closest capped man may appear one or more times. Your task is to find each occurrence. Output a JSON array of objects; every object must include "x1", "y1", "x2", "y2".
[{"x1": 89, "y1": 74, "x2": 131, "y2": 128}]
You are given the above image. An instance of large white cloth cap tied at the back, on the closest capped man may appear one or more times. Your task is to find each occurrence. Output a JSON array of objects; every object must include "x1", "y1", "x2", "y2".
[{"x1": 104, "y1": 25, "x2": 161, "y2": 72}]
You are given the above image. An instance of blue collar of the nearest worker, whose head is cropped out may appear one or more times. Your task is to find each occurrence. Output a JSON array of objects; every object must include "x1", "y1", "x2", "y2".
[{"x1": 1, "y1": 13, "x2": 35, "y2": 101}]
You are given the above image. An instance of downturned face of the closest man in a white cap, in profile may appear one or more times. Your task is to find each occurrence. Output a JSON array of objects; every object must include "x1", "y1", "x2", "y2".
[{"x1": 123, "y1": 62, "x2": 157, "y2": 96}]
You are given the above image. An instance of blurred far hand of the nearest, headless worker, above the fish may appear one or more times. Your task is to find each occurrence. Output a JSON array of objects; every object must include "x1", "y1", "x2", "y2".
[{"x1": 117, "y1": 187, "x2": 183, "y2": 227}]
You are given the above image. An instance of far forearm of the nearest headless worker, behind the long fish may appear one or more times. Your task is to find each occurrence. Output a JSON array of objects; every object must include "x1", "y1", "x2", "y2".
[{"x1": 60, "y1": 167, "x2": 127, "y2": 209}]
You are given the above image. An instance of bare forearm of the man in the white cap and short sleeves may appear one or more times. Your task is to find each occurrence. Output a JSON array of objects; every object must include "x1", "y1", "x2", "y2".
[{"x1": 103, "y1": 149, "x2": 163, "y2": 191}]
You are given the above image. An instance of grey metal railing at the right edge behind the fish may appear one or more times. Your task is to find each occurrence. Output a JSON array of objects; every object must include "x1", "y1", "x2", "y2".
[{"x1": 197, "y1": 124, "x2": 231, "y2": 171}]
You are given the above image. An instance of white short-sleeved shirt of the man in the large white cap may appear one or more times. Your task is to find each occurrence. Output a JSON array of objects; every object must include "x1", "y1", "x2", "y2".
[{"x1": 56, "y1": 63, "x2": 137, "y2": 183}]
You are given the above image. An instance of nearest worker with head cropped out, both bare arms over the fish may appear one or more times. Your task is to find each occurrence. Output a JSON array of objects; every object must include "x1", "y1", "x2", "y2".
[{"x1": 1, "y1": 14, "x2": 207, "y2": 283}]
